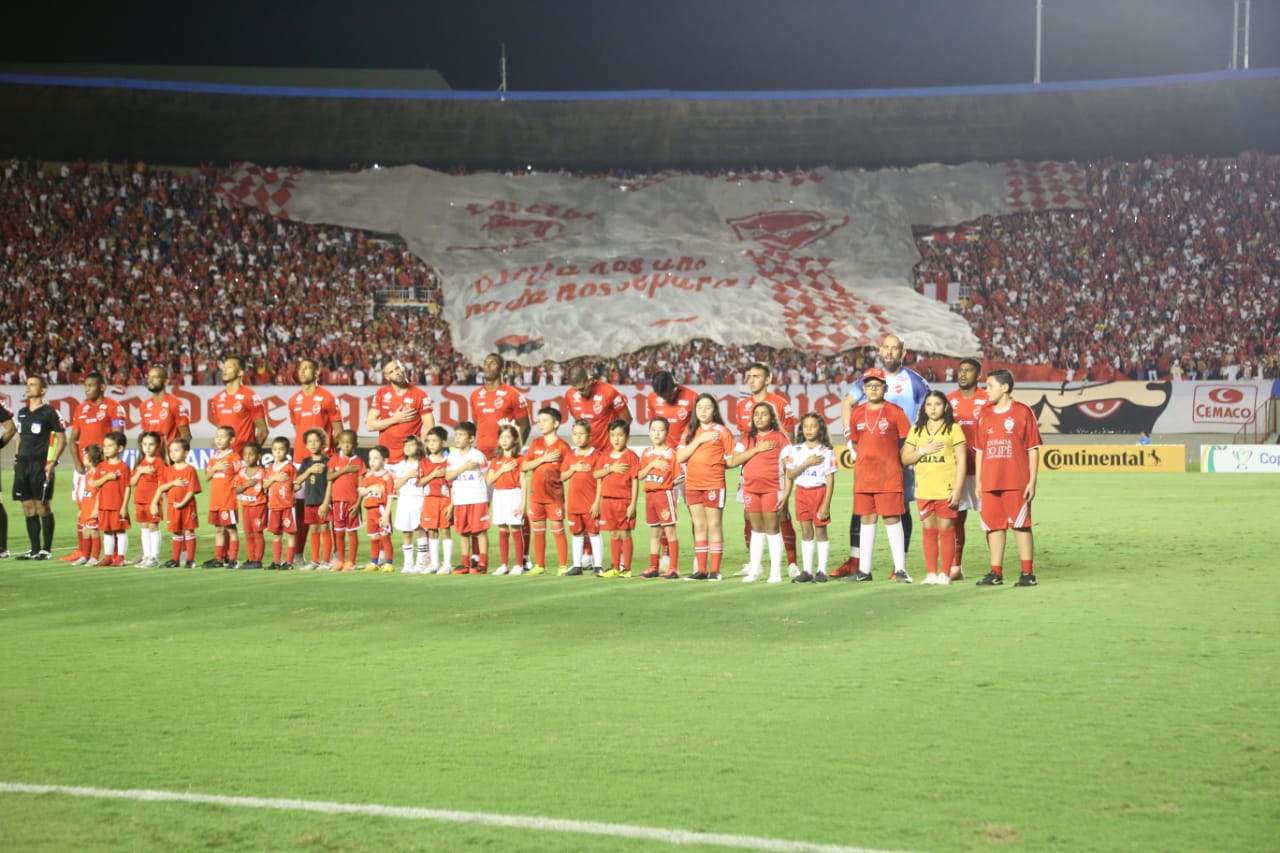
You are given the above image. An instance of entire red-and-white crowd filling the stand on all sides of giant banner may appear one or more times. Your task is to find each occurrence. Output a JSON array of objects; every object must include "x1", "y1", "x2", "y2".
[{"x1": 0, "y1": 155, "x2": 1280, "y2": 386}]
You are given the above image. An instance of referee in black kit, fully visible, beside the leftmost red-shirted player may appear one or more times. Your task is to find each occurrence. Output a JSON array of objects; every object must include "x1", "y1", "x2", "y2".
[{"x1": 13, "y1": 377, "x2": 67, "y2": 560}]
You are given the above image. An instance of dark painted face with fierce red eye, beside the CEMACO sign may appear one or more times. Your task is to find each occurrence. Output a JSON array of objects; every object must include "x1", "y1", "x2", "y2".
[{"x1": 1023, "y1": 382, "x2": 1172, "y2": 435}]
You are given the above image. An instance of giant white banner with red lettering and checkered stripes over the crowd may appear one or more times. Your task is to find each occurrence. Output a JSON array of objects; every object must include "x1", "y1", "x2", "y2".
[{"x1": 219, "y1": 163, "x2": 1088, "y2": 364}]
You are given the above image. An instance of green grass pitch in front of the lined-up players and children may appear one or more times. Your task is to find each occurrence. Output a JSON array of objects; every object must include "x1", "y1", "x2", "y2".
[{"x1": 0, "y1": 473, "x2": 1280, "y2": 853}]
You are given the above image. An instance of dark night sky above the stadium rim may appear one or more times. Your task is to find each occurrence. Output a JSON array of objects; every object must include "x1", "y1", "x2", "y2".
[{"x1": 0, "y1": 0, "x2": 1280, "y2": 91}]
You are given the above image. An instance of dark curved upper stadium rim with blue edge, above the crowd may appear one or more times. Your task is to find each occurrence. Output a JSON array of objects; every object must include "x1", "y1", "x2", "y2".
[{"x1": 0, "y1": 67, "x2": 1280, "y2": 170}]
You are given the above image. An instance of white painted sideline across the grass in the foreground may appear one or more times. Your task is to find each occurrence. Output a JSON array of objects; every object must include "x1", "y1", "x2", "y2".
[{"x1": 0, "y1": 783, "x2": 921, "y2": 853}]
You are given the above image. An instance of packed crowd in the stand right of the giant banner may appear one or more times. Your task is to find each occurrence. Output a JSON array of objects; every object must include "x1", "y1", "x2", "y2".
[{"x1": 916, "y1": 155, "x2": 1280, "y2": 379}]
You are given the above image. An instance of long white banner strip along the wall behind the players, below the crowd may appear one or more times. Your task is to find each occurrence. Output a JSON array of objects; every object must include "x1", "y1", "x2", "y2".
[{"x1": 0, "y1": 380, "x2": 1272, "y2": 444}]
